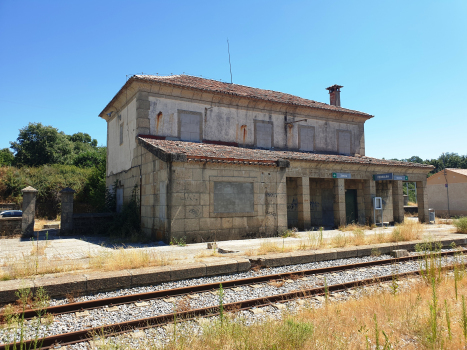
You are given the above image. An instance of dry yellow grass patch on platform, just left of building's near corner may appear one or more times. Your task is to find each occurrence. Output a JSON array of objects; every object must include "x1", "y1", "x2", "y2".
[{"x1": 89, "y1": 247, "x2": 171, "y2": 271}]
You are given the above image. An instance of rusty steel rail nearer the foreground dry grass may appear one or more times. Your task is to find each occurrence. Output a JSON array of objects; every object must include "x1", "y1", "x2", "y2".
[{"x1": 0, "y1": 265, "x2": 455, "y2": 350}]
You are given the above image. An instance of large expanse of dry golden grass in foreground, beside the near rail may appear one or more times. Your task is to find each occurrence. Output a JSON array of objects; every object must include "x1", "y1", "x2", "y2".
[{"x1": 94, "y1": 266, "x2": 467, "y2": 350}]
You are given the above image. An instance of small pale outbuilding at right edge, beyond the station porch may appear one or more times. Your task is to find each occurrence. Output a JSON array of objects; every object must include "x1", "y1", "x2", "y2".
[{"x1": 426, "y1": 168, "x2": 467, "y2": 216}]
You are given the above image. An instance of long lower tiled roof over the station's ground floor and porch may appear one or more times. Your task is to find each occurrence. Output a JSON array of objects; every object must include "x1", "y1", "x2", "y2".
[{"x1": 138, "y1": 136, "x2": 433, "y2": 169}]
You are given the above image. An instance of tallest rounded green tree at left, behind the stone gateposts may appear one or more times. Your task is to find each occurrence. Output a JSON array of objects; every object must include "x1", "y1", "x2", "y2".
[{"x1": 10, "y1": 123, "x2": 73, "y2": 166}]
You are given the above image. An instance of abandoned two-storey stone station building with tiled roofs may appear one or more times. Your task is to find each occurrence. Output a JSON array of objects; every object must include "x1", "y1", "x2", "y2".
[{"x1": 99, "y1": 75, "x2": 432, "y2": 242}]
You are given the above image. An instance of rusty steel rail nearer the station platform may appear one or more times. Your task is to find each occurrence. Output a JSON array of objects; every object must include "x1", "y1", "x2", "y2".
[{"x1": 6, "y1": 249, "x2": 467, "y2": 324}]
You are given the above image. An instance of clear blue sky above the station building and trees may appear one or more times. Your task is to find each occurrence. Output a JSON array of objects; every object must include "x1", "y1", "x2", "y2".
[{"x1": 0, "y1": 0, "x2": 467, "y2": 159}]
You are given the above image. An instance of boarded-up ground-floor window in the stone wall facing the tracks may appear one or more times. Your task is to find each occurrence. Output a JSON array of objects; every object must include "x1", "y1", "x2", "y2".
[{"x1": 214, "y1": 181, "x2": 254, "y2": 213}]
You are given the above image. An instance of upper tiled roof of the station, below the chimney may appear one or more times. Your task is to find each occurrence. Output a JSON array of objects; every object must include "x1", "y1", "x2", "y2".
[{"x1": 104, "y1": 74, "x2": 373, "y2": 119}]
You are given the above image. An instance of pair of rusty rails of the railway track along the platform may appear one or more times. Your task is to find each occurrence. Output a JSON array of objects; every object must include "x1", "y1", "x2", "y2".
[{"x1": 0, "y1": 250, "x2": 464, "y2": 350}]
